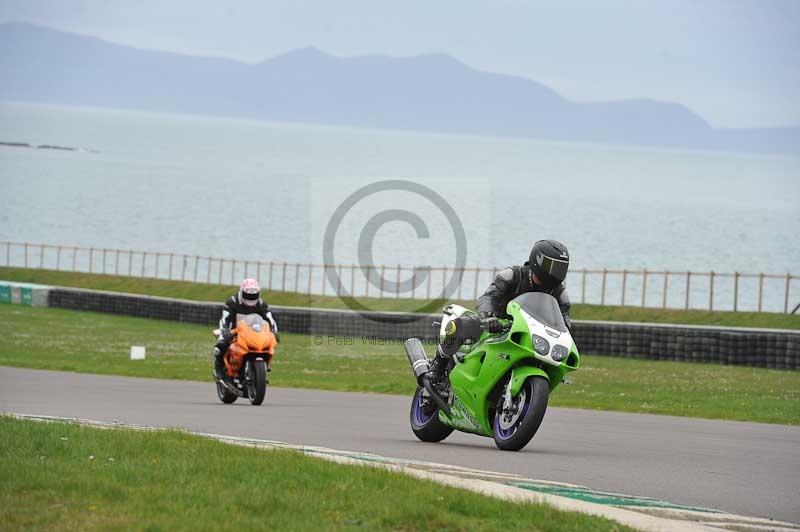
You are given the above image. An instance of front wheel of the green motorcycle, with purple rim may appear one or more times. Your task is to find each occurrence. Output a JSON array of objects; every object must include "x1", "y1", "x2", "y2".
[{"x1": 493, "y1": 377, "x2": 550, "y2": 451}]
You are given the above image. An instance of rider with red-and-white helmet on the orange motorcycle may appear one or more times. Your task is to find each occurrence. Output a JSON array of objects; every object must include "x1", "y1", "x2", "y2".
[{"x1": 214, "y1": 279, "x2": 280, "y2": 379}]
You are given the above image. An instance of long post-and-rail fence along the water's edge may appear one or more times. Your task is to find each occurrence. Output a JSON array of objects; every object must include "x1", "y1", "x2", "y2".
[{"x1": 0, "y1": 241, "x2": 800, "y2": 314}]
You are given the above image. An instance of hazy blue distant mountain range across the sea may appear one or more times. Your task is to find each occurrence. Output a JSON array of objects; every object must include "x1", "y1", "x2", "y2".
[{"x1": 0, "y1": 23, "x2": 800, "y2": 154}]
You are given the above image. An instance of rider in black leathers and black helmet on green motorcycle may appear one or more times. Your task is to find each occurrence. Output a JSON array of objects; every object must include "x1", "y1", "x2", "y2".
[{"x1": 431, "y1": 240, "x2": 572, "y2": 381}]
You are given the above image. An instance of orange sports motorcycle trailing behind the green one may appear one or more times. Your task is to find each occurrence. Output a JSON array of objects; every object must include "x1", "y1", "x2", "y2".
[{"x1": 214, "y1": 314, "x2": 277, "y2": 405}]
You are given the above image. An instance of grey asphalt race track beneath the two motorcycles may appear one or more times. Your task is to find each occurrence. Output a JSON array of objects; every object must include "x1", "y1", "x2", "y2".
[{"x1": 0, "y1": 367, "x2": 800, "y2": 523}]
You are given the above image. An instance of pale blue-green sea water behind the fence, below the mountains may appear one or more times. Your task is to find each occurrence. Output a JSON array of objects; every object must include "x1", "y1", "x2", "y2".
[{"x1": 0, "y1": 103, "x2": 800, "y2": 308}]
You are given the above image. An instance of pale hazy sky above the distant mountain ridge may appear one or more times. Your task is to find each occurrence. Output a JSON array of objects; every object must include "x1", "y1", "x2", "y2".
[{"x1": 0, "y1": 0, "x2": 800, "y2": 127}]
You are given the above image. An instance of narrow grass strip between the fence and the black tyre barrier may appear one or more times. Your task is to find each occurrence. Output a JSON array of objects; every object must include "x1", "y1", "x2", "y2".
[{"x1": 0, "y1": 267, "x2": 800, "y2": 329}]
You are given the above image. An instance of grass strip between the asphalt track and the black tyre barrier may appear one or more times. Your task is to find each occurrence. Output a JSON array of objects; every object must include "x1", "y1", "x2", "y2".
[{"x1": 0, "y1": 304, "x2": 800, "y2": 425}]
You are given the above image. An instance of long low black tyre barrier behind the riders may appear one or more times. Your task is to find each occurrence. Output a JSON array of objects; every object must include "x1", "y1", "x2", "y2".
[{"x1": 0, "y1": 283, "x2": 800, "y2": 370}]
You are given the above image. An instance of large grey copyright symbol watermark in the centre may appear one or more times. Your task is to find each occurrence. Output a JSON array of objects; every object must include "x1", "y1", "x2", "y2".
[{"x1": 322, "y1": 180, "x2": 467, "y2": 323}]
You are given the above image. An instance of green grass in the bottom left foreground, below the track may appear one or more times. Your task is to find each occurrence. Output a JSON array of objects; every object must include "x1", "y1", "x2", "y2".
[{"x1": 0, "y1": 416, "x2": 630, "y2": 531}]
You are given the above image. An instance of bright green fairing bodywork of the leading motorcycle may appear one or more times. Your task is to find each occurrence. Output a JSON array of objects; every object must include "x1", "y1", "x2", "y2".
[{"x1": 439, "y1": 301, "x2": 580, "y2": 437}]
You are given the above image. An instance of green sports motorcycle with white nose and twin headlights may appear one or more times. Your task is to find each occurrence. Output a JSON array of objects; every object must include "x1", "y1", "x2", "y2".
[{"x1": 405, "y1": 292, "x2": 580, "y2": 451}]
